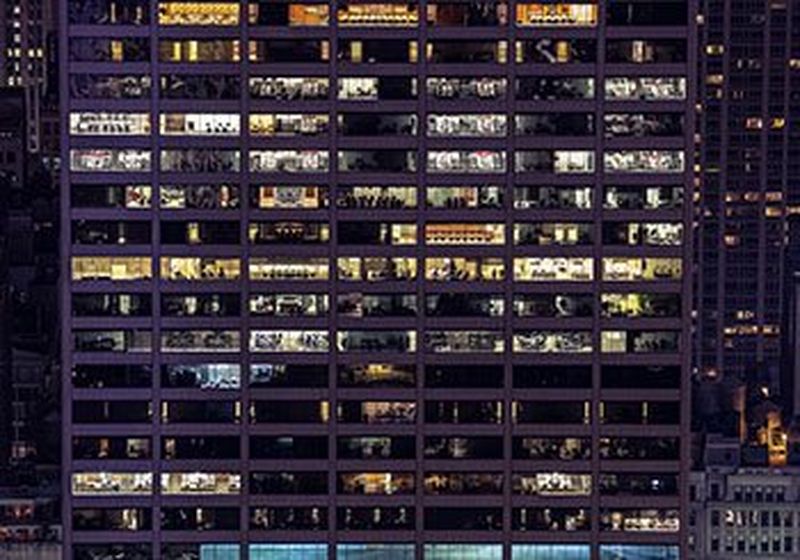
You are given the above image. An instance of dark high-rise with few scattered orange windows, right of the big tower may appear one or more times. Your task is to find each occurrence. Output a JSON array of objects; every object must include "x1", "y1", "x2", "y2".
[{"x1": 695, "y1": 0, "x2": 800, "y2": 395}]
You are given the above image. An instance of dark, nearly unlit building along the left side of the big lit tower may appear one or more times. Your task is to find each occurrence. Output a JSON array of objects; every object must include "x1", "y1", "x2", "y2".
[{"x1": 0, "y1": 88, "x2": 59, "y2": 469}]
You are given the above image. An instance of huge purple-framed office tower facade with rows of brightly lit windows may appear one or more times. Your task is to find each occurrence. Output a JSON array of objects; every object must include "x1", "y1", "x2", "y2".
[{"x1": 60, "y1": 0, "x2": 697, "y2": 560}]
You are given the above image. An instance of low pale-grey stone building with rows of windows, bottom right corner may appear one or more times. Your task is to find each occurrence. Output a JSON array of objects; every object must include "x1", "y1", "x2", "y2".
[{"x1": 687, "y1": 439, "x2": 800, "y2": 560}]
